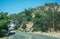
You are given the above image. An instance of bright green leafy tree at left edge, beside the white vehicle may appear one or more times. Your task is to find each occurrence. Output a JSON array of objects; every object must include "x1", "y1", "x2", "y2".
[{"x1": 0, "y1": 12, "x2": 9, "y2": 35}]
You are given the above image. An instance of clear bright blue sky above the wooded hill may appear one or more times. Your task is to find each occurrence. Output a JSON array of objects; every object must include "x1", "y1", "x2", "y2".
[{"x1": 0, "y1": 0, "x2": 60, "y2": 14}]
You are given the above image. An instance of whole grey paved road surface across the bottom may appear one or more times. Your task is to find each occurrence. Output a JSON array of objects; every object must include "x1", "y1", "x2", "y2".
[{"x1": 8, "y1": 30, "x2": 60, "y2": 39}]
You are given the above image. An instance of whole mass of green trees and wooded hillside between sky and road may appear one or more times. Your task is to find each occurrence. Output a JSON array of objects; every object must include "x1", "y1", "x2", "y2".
[{"x1": 0, "y1": 3, "x2": 60, "y2": 35}]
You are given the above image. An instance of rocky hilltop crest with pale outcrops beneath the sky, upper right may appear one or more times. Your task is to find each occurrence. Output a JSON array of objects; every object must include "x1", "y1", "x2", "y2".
[{"x1": 37, "y1": 3, "x2": 60, "y2": 11}]
